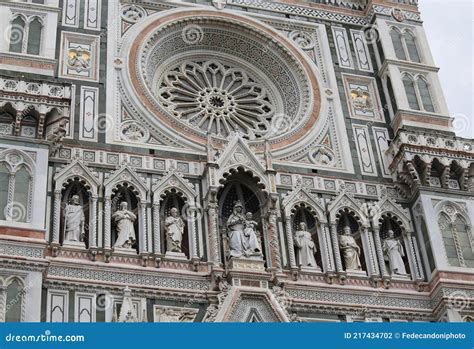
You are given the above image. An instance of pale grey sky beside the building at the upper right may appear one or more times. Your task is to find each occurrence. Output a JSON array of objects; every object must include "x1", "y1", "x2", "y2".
[{"x1": 419, "y1": 0, "x2": 474, "y2": 138}]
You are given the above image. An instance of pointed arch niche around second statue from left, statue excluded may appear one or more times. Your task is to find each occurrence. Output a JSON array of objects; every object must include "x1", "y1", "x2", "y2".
[{"x1": 104, "y1": 165, "x2": 149, "y2": 254}]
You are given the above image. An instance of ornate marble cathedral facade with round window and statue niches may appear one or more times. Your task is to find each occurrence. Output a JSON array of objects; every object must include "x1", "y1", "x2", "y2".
[{"x1": 0, "y1": 0, "x2": 474, "y2": 322}]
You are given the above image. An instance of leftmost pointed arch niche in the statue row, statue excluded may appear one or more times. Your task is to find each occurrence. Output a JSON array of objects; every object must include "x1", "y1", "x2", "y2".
[{"x1": 52, "y1": 160, "x2": 100, "y2": 248}]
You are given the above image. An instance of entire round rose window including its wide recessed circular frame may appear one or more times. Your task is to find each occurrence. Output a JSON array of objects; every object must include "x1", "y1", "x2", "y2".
[{"x1": 124, "y1": 10, "x2": 320, "y2": 149}]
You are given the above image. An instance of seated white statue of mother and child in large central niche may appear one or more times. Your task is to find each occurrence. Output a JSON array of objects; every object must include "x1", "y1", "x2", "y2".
[{"x1": 226, "y1": 201, "x2": 262, "y2": 257}]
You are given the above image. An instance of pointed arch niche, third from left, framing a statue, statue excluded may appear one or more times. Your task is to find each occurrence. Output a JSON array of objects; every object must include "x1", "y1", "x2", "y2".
[{"x1": 153, "y1": 169, "x2": 200, "y2": 259}]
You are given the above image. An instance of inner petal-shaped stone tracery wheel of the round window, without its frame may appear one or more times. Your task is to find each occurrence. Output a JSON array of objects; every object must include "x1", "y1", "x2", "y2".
[{"x1": 158, "y1": 60, "x2": 275, "y2": 139}]
